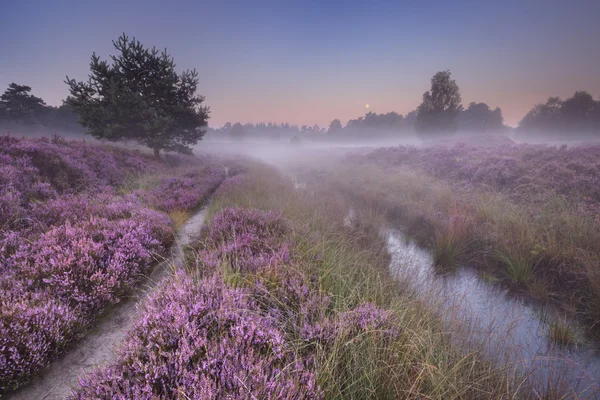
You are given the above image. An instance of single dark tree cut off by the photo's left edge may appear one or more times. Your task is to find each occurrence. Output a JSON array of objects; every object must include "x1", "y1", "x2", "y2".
[{"x1": 0, "y1": 83, "x2": 46, "y2": 124}]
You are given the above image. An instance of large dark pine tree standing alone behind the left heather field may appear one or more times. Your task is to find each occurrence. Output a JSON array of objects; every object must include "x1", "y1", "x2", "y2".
[{"x1": 65, "y1": 34, "x2": 209, "y2": 157}]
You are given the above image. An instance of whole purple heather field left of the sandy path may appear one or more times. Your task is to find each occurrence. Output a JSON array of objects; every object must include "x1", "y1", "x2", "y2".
[{"x1": 0, "y1": 136, "x2": 225, "y2": 391}]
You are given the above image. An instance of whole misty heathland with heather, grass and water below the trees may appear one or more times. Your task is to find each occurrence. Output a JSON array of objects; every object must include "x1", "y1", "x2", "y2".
[{"x1": 0, "y1": 137, "x2": 600, "y2": 399}]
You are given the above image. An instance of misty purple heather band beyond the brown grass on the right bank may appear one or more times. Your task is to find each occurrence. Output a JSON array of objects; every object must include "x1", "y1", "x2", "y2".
[{"x1": 364, "y1": 144, "x2": 600, "y2": 213}]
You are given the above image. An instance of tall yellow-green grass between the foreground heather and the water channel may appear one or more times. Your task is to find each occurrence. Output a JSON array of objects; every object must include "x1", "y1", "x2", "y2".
[{"x1": 202, "y1": 166, "x2": 548, "y2": 399}]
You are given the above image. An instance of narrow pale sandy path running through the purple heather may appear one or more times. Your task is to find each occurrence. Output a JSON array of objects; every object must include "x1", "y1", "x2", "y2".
[{"x1": 6, "y1": 208, "x2": 206, "y2": 400}]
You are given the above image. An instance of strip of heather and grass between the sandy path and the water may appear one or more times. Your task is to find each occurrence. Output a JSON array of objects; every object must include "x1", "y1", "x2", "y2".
[{"x1": 69, "y1": 164, "x2": 592, "y2": 399}]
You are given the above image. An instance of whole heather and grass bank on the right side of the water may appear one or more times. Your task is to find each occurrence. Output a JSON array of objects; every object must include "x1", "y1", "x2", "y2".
[{"x1": 292, "y1": 144, "x2": 600, "y2": 335}]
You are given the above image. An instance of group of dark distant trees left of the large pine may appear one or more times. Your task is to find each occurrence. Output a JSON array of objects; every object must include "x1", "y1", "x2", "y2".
[{"x1": 0, "y1": 83, "x2": 83, "y2": 133}]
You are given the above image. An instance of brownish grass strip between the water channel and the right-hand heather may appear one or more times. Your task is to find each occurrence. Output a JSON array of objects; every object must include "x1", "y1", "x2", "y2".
[{"x1": 302, "y1": 159, "x2": 600, "y2": 336}]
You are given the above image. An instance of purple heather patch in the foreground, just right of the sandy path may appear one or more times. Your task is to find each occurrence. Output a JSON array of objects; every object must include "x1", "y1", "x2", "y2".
[{"x1": 74, "y1": 208, "x2": 400, "y2": 399}]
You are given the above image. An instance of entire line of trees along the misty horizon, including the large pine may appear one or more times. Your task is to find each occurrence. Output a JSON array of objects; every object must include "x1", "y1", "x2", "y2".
[{"x1": 5, "y1": 54, "x2": 600, "y2": 146}]
